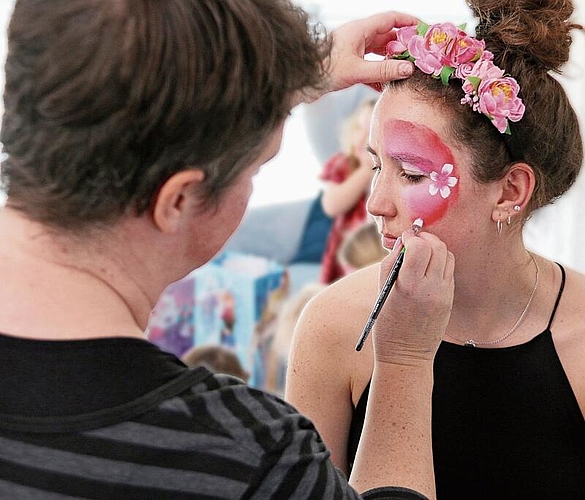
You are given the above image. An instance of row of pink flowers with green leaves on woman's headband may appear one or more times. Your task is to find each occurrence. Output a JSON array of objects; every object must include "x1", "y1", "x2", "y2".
[{"x1": 386, "y1": 22, "x2": 525, "y2": 135}]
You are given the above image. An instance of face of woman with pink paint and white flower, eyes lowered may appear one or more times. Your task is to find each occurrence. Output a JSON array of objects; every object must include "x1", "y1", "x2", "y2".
[{"x1": 368, "y1": 90, "x2": 490, "y2": 247}]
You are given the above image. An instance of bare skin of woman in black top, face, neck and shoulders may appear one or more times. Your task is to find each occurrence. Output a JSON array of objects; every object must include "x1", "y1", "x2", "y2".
[{"x1": 285, "y1": 85, "x2": 585, "y2": 472}]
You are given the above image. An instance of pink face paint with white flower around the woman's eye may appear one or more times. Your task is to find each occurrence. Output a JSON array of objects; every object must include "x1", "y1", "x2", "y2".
[{"x1": 384, "y1": 120, "x2": 459, "y2": 226}]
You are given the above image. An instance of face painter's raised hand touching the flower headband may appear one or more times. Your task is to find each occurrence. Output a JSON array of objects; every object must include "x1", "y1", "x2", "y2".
[{"x1": 296, "y1": 12, "x2": 418, "y2": 104}]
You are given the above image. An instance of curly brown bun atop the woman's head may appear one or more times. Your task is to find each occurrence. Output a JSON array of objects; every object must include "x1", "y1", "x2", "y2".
[{"x1": 468, "y1": 0, "x2": 582, "y2": 74}]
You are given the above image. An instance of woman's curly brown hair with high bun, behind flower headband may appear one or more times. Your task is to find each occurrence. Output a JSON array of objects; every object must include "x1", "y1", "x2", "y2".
[{"x1": 386, "y1": 0, "x2": 583, "y2": 213}]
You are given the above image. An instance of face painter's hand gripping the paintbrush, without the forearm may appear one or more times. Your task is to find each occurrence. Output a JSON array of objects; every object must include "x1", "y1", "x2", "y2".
[{"x1": 372, "y1": 230, "x2": 455, "y2": 365}]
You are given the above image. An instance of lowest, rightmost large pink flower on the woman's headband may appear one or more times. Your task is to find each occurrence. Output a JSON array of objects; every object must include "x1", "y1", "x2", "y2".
[{"x1": 477, "y1": 77, "x2": 525, "y2": 133}]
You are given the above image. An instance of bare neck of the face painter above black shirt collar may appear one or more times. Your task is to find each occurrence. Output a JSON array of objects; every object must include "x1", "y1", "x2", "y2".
[{"x1": 0, "y1": 209, "x2": 168, "y2": 339}]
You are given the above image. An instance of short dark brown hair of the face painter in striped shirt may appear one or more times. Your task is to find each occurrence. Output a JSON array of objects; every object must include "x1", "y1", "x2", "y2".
[{"x1": 0, "y1": 0, "x2": 330, "y2": 230}]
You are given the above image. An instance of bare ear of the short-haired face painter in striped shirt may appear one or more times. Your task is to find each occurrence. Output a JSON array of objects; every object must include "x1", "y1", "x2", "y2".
[{"x1": 152, "y1": 168, "x2": 205, "y2": 234}]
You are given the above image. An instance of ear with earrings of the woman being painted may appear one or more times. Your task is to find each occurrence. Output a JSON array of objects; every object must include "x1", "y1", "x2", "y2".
[{"x1": 492, "y1": 163, "x2": 536, "y2": 222}]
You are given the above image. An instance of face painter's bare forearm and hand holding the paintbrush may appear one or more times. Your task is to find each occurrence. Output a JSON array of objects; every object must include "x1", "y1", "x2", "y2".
[{"x1": 350, "y1": 233, "x2": 454, "y2": 498}]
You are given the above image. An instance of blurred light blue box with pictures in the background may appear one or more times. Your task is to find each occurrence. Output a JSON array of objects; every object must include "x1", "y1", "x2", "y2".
[{"x1": 192, "y1": 252, "x2": 289, "y2": 387}]
